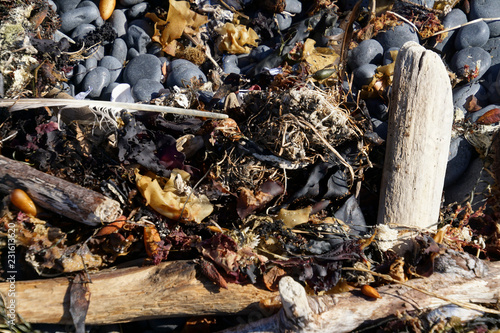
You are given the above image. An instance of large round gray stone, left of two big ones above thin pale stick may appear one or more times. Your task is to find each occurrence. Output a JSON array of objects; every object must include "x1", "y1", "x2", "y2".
[{"x1": 123, "y1": 54, "x2": 161, "y2": 86}]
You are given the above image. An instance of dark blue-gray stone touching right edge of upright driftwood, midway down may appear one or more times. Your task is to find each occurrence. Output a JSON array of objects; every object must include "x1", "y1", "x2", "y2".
[{"x1": 444, "y1": 136, "x2": 474, "y2": 186}]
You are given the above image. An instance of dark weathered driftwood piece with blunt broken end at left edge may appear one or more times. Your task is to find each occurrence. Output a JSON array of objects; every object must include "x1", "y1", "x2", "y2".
[{"x1": 0, "y1": 156, "x2": 122, "y2": 225}]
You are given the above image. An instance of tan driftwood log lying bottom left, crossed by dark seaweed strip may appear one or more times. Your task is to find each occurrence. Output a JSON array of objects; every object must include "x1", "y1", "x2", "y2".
[{"x1": 0, "y1": 261, "x2": 278, "y2": 324}]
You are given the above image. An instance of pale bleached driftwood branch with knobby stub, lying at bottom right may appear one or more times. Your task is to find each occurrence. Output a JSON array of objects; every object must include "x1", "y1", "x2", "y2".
[{"x1": 223, "y1": 252, "x2": 500, "y2": 333}]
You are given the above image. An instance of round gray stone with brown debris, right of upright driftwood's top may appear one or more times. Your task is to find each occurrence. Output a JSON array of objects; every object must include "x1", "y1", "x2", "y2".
[{"x1": 450, "y1": 47, "x2": 491, "y2": 81}]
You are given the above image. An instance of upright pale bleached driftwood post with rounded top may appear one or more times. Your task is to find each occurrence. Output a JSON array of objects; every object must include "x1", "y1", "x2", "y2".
[{"x1": 378, "y1": 42, "x2": 453, "y2": 228}]
